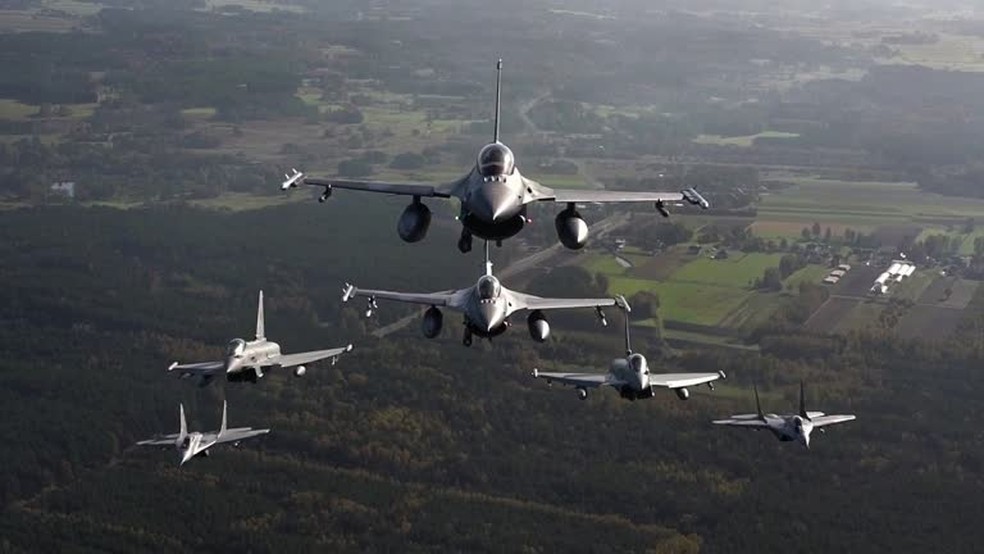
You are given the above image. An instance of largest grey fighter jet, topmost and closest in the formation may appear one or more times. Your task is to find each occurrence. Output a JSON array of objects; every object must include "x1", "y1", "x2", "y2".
[{"x1": 281, "y1": 59, "x2": 709, "y2": 252}]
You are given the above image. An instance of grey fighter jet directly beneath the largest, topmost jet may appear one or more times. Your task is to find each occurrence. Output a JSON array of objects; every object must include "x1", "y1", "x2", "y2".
[{"x1": 342, "y1": 242, "x2": 622, "y2": 346}]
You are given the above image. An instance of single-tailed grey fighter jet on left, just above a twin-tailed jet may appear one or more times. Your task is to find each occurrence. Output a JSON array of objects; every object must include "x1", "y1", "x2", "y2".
[{"x1": 167, "y1": 290, "x2": 352, "y2": 387}]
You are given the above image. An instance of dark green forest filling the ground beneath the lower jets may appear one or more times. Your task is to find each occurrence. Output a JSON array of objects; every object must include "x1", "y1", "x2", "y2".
[{"x1": 0, "y1": 201, "x2": 984, "y2": 552}]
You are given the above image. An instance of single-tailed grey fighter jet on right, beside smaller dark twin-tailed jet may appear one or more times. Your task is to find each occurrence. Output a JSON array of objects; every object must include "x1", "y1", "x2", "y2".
[{"x1": 533, "y1": 298, "x2": 725, "y2": 401}]
